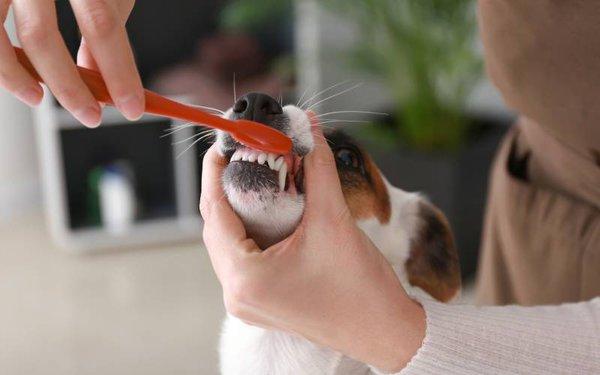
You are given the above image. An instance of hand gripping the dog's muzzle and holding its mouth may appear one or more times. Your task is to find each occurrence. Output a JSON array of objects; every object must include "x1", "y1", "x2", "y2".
[{"x1": 200, "y1": 127, "x2": 425, "y2": 371}]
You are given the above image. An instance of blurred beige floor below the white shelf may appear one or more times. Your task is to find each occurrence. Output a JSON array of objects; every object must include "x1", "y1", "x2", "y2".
[{"x1": 0, "y1": 215, "x2": 224, "y2": 375}]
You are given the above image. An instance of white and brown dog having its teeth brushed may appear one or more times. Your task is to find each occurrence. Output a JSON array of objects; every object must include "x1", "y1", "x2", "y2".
[{"x1": 215, "y1": 93, "x2": 461, "y2": 375}]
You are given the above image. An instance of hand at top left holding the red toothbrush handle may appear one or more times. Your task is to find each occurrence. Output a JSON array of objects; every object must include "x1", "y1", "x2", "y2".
[{"x1": 0, "y1": 0, "x2": 145, "y2": 126}]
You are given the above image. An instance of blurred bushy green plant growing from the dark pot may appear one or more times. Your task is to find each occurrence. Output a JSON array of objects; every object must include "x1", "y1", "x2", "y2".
[{"x1": 322, "y1": 0, "x2": 482, "y2": 150}]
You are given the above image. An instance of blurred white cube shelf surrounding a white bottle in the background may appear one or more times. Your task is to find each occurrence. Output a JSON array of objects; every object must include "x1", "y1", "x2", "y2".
[{"x1": 35, "y1": 90, "x2": 209, "y2": 253}]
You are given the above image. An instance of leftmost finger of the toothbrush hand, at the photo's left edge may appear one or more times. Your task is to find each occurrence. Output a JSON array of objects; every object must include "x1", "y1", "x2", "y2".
[{"x1": 0, "y1": 0, "x2": 44, "y2": 106}]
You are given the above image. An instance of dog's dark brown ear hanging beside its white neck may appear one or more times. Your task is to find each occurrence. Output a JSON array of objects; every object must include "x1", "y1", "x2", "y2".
[{"x1": 406, "y1": 200, "x2": 461, "y2": 302}]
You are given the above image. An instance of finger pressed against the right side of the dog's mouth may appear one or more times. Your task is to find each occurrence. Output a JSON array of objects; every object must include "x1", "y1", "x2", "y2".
[{"x1": 304, "y1": 116, "x2": 346, "y2": 215}]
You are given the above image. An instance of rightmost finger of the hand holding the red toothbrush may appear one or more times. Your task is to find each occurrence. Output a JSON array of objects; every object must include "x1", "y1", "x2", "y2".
[{"x1": 71, "y1": 0, "x2": 145, "y2": 120}]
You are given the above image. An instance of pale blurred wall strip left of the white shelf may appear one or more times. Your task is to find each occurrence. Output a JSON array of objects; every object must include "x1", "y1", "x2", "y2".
[{"x1": 0, "y1": 10, "x2": 41, "y2": 220}]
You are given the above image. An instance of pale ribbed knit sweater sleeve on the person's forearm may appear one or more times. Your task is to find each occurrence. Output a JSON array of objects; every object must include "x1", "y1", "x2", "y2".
[{"x1": 375, "y1": 297, "x2": 600, "y2": 375}]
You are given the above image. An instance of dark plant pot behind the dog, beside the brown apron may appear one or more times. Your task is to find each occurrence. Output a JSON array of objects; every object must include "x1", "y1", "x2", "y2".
[{"x1": 360, "y1": 118, "x2": 510, "y2": 278}]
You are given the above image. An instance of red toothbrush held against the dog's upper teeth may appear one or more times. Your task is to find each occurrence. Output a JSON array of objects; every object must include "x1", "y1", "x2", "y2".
[{"x1": 14, "y1": 47, "x2": 292, "y2": 155}]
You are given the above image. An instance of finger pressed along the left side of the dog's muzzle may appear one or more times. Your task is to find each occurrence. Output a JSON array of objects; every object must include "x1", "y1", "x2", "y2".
[{"x1": 200, "y1": 145, "x2": 247, "y2": 251}]
